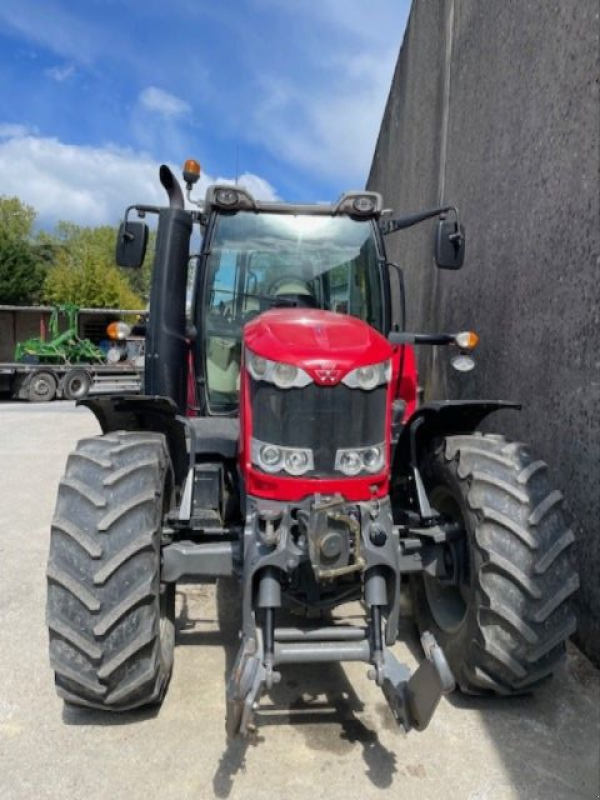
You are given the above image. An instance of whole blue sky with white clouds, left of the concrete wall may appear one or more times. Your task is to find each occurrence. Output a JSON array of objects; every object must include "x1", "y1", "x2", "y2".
[{"x1": 0, "y1": 0, "x2": 410, "y2": 226}]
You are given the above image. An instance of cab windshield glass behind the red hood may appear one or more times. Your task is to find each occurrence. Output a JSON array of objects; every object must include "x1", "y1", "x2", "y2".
[{"x1": 197, "y1": 212, "x2": 383, "y2": 413}]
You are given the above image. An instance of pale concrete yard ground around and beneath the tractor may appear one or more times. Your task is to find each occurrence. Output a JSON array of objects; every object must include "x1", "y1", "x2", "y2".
[{"x1": 0, "y1": 403, "x2": 600, "y2": 800}]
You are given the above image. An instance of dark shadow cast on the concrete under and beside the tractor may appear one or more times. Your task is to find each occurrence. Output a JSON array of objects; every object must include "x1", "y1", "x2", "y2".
[{"x1": 58, "y1": 587, "x2": 600, "y2": 800}]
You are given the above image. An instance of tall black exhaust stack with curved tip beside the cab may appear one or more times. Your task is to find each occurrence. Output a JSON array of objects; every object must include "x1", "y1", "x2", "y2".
[{"x1": 144, "y1": 164, "x2": 192, "y2": 414}]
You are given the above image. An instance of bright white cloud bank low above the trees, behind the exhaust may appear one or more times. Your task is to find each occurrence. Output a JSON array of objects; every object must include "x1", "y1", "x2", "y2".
[{"x1": 0, "y1": 130, "x2": 277, "y2": 227}]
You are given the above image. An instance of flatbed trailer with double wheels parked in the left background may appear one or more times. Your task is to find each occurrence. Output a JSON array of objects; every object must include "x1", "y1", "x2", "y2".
[{"x1": 0, "y1": 362, "x2": 144, "y2": 403}]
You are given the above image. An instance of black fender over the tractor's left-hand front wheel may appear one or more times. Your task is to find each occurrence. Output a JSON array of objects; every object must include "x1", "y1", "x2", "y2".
[{"x1": 77, "y1": 395, "x2": 189, "y2": 486}]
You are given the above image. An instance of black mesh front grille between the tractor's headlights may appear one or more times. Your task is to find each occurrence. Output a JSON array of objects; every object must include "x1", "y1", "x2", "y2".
[{"x1": 250, "y1": 379, "x2": 387, "y2": 477}]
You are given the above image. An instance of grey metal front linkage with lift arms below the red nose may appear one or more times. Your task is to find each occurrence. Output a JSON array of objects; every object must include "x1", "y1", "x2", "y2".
[{"x1": 226, "y1": 496, "x2": 454, "y2": 736}]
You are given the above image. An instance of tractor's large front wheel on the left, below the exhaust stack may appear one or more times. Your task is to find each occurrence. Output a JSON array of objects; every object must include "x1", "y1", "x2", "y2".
[{"x1": 46, "y1": 432, "x2": 175, "y2": 711}]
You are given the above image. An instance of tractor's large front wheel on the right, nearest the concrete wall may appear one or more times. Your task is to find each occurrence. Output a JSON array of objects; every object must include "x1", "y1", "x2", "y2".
[{"x1": 412, "y1": 434, "x2": 579, "y2": 695}]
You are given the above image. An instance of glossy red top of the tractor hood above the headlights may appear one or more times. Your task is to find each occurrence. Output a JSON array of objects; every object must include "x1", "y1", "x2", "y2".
[{"x1": 244, "y1": 308, "x2": 392, "y2": 385}]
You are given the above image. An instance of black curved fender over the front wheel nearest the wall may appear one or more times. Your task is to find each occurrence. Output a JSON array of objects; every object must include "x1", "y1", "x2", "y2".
[{"x1": 393, "y1": 400, "x2": 521, "y2": 473}]
